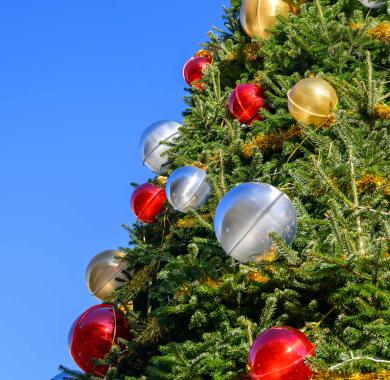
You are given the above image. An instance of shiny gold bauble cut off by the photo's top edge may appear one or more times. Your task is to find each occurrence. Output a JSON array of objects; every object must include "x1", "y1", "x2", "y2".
[{"x1": 240, "y1": 0, "x2": 289, "y2": 38}]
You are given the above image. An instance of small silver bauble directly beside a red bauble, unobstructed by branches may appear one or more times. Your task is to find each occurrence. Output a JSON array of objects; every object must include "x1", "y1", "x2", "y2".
[{"x1": 166, "y1": 166, "x2": 211, "y2": 212}]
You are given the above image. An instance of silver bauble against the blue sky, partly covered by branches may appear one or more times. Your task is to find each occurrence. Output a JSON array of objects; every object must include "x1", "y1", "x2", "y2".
[{"x1": 141, "y1": 121, "x2": 181, "y2": 174}]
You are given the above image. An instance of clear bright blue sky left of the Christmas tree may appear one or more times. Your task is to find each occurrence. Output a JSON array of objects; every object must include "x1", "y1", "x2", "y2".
[{"x1": 0, "y1": 0, "x2": 228, "y2": 380}]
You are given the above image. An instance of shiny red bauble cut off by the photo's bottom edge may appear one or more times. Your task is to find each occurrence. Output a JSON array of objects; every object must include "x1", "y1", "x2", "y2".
[{"x1": 249, "y1": 327, "x2": 315, "y2": 380}]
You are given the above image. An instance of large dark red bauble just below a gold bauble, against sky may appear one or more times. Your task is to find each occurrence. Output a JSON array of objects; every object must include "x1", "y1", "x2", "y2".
[{"x1": 68, "y1": 304, "x2": 130, "y2": 377}]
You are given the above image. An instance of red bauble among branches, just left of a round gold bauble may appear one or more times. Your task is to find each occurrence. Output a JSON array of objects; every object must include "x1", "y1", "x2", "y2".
[{"x1": 229, "y1": 83, "x2": 268, "y2": 124}]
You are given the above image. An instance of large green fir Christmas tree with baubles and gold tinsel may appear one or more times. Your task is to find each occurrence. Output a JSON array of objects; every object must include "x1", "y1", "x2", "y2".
[{"x1": 59, "y1": 0, "x2": 390, "y2": 380}]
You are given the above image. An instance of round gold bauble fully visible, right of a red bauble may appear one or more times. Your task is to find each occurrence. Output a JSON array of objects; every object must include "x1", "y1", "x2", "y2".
[{"x1": 287, "y1": 78, "x2": 338, "y2": 125}]
